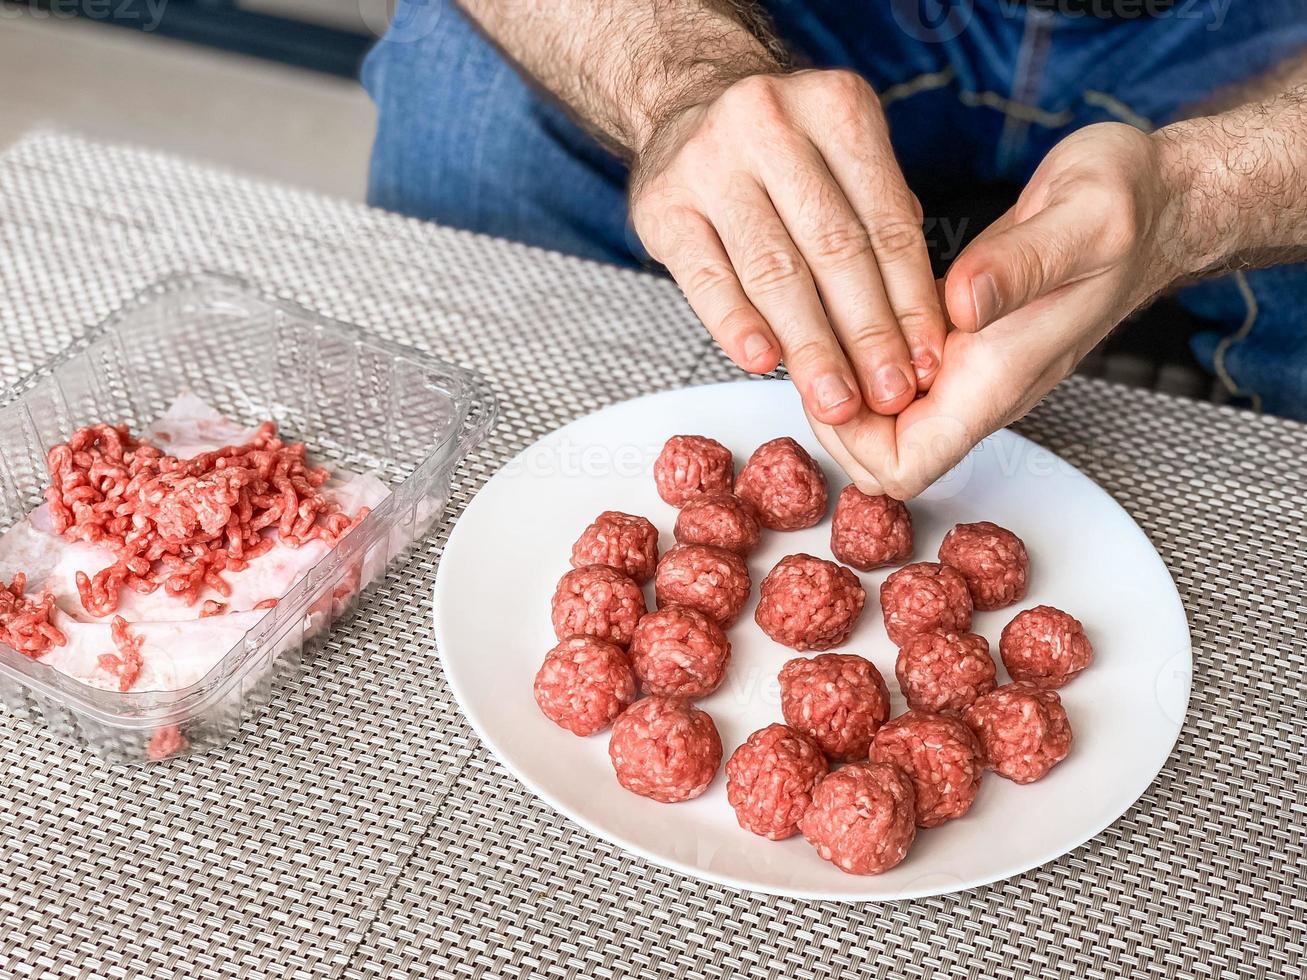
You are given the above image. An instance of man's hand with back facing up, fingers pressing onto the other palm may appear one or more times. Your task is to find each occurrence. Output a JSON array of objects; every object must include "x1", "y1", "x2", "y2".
[{"x1": 631, "y1": 71, "x2": 945, "y2": 425}]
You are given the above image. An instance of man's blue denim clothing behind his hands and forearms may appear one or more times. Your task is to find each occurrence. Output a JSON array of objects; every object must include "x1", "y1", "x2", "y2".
[{"x1": 363, "y1": 0, "x2": 1307, "y2": 418}]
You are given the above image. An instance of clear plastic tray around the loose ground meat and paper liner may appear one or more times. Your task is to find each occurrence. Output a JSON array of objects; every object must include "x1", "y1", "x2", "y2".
[{"x1": 0, "y1": 274, "x2": 495, "y2": 763}]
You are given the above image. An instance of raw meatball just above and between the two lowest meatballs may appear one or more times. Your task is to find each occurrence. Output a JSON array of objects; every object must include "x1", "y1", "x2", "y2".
[{"x1": 780, "y1": 653, "x2": 890, "y2": 762}]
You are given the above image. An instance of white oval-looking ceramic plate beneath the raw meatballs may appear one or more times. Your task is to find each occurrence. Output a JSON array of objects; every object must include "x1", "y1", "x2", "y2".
[{"x1": 435, "y1": 382, "x2": 1192, "y2": 900}]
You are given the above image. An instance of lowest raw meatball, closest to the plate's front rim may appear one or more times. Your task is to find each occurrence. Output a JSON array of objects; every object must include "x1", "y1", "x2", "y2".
[{"x1": 799, "y1": 762, "x2": 916, "y2": 874}]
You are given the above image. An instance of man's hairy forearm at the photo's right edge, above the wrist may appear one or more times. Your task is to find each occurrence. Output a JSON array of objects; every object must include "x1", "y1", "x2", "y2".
[{"x1": 1157, "y1": 75, "x2": 1307, "y2": 276}]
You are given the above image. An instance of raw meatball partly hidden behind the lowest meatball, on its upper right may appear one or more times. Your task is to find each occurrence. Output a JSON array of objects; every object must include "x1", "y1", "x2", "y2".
[{"x1": 870, "y1": 711, "x2": 984, "y2": 827}]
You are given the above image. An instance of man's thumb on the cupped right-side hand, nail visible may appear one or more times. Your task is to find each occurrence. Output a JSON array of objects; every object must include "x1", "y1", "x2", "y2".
[{"x1": 944, "y1": 203, "x2": 1097, "y2": 332}]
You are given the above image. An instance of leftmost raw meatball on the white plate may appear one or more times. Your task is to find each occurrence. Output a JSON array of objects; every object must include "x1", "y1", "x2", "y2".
[{"x1": 536, "y1": 636, "x2": 635, "y2": 736}]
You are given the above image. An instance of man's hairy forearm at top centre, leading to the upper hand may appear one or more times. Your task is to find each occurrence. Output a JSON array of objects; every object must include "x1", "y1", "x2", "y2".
[{"x1": 459, "y1": 0, "x2": 783, "y2": 154}]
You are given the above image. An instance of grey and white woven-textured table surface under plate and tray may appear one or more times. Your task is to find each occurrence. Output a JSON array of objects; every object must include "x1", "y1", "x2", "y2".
[{"x1": 0, "y1": 135, "x2": 1307, "y2": 980}]
